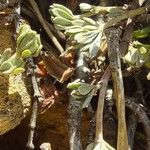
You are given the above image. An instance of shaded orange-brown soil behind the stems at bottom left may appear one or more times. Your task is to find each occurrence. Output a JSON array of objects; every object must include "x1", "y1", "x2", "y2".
[{"x1": 0, "y1": 92, "x2": 89, "y2": 150}]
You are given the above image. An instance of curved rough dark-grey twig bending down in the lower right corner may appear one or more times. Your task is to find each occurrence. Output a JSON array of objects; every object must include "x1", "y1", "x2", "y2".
[{"x1": 126, "y1": 98, "x2": 150, "y2": 150}]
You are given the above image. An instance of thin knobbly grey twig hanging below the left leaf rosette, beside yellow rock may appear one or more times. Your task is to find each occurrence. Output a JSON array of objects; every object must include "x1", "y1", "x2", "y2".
[{"x1": 26, "y1": 58, "x2": 43, "y2": 150}]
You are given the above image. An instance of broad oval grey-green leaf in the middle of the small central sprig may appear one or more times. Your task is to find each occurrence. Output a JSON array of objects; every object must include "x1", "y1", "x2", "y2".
[{"x1": 78, "y1": 83, "x2": 93, "y2": 95}]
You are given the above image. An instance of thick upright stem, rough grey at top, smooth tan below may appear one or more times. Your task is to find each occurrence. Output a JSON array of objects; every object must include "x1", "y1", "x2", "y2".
[{"x1": 105, "y1": 27, "x2": 129, "y2": 150}]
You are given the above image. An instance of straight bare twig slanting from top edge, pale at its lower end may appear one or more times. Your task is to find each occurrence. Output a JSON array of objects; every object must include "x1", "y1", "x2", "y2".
[{"x1": 29, "y1": 0, "x2": 64, "y2": 53}]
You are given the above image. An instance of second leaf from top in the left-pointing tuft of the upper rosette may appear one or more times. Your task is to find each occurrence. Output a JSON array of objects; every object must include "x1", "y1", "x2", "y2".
[{"x1": 51, "y1": 8, "x2": 73, "y2": 20}]
